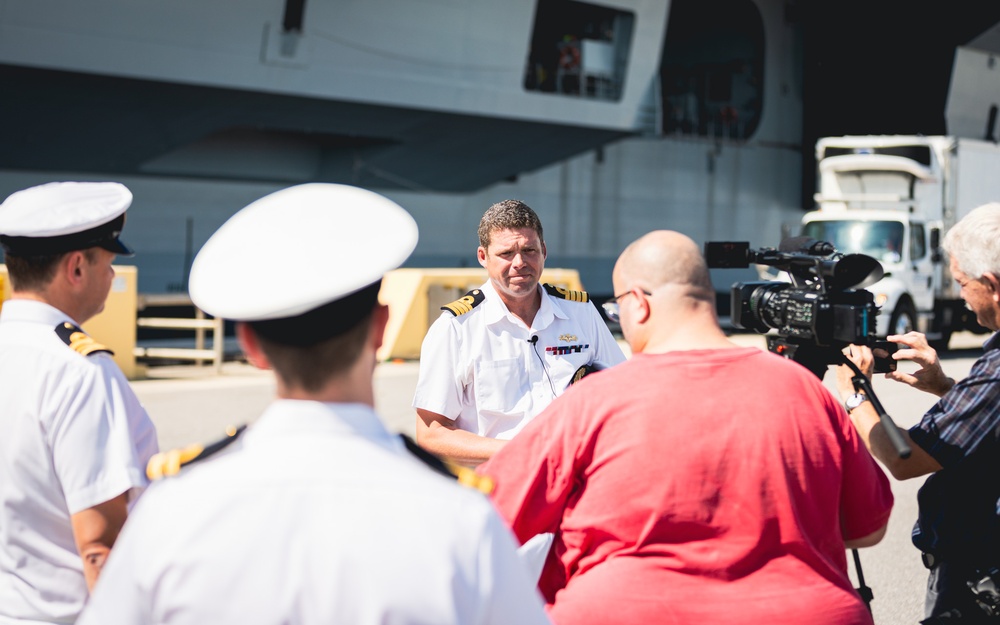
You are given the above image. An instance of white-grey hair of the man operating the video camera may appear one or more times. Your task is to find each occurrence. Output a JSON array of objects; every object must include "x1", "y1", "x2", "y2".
[{"x1": 942, "y1": 202, "x2": 1000, "y2": 279}]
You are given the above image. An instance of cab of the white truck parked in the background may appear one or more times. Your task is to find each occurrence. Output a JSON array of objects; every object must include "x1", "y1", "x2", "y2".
[{"x1": 802, "y1": 136, "x2": 950, "y2": 341}]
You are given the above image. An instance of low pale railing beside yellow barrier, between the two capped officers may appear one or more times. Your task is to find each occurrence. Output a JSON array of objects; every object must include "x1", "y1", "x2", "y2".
[{"x1": 135, "y1": 293, "x2": 225, "y2": 373}]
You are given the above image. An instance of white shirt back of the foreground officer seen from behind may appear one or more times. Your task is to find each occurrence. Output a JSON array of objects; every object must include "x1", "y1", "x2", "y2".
[{"x1": 80, "y1": 400, "x2": 548, "y2": 625}]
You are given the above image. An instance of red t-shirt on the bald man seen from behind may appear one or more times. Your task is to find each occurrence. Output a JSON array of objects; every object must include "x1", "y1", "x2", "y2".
[{"x1": 480, "y1": 348, "x2": 892, "y2": 625}]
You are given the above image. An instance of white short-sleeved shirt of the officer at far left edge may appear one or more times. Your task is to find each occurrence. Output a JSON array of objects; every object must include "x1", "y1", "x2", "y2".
[{"x1": 0, "y1": 300, "x2": 157, "y2": 623}]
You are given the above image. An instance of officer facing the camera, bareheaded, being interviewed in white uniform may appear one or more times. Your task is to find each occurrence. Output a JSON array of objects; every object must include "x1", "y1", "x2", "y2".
[{"x1": 413, "y1": 200, "x2": 625, "y2": 465}]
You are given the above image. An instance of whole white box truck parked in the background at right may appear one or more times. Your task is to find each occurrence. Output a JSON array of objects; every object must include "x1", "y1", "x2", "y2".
[{"x1": 802, "y1": 135, "x2": 1000, "y2": 348}]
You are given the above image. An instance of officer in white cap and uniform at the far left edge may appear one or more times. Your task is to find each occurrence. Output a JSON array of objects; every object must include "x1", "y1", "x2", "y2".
[{"x1": 0, "y1": 182, "x2": 157, "y2": 623}]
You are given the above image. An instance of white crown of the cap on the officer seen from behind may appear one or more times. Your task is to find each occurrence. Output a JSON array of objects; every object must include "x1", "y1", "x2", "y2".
[{"x1": 189, "y1": 183, "x2": 417, "y2": 321}]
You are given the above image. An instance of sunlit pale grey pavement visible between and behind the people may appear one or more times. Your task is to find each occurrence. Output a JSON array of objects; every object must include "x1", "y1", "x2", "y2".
[{"x1": 133, "y1": 334, "x2": 985, "y2": 625}]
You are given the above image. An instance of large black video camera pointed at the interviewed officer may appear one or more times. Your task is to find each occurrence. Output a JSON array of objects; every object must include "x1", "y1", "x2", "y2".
[{"x1": 705, "y1": 237, "x2": 896, "y2": 378}]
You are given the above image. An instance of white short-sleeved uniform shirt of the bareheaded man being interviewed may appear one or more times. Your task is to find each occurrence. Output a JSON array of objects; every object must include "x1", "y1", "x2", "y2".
[{"x1": 413, "y1": 280, "x2": 625, "y2": 439}]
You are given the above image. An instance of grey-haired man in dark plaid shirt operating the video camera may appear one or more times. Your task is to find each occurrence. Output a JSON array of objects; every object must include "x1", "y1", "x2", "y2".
[{"x1": 837, "y1": 203, "x2": 1000, "y2": 624}]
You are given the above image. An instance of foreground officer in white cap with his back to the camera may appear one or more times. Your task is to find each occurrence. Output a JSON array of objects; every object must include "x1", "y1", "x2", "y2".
[{"x1": 80, "y1": 183, "x2": 548, "y2": 625}]
